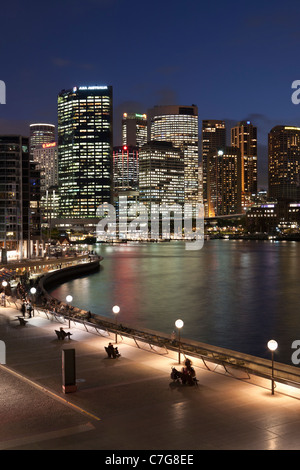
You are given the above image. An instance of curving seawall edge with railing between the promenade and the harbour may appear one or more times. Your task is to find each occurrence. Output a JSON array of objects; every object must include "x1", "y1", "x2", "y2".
[{"x1": 29, "y1": 258, "x2": 300, "y2": 388}]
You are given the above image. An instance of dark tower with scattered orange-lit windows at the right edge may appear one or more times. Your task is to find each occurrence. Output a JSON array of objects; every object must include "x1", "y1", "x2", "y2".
[{"x1": 268, "y1": 126, "x2": 300, "y2": 201}]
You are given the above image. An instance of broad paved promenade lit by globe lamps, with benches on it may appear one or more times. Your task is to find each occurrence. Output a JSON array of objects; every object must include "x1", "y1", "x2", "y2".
[{"x1": 0, "y1": 302, "x2": 300, "y2": 451}]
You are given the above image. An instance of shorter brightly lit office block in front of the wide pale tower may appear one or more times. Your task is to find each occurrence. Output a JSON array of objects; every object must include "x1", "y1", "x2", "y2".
[{"x1": 139, "y1": 141, "x2": 184, "y2": 209}]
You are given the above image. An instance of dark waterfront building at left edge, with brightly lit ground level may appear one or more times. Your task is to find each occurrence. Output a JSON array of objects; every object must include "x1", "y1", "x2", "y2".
[{"x1": 0, "y1": 135, "x2": 41, "y2": 262}]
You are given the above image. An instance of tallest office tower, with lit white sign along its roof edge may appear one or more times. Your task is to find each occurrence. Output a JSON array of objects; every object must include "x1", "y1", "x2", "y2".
[{"x1": 58, "y1": 86, "x2": 113, "y2": 218}]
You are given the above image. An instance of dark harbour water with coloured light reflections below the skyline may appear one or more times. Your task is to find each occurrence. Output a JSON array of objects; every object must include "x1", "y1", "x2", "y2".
[{"x1": 52, "y1": 240, "x2": 300, "y2": 364}]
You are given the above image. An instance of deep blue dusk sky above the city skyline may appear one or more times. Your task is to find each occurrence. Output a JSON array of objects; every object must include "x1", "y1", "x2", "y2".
[{"x1": 0, "y1": 0, "x2": 300, "y2": 187}]
